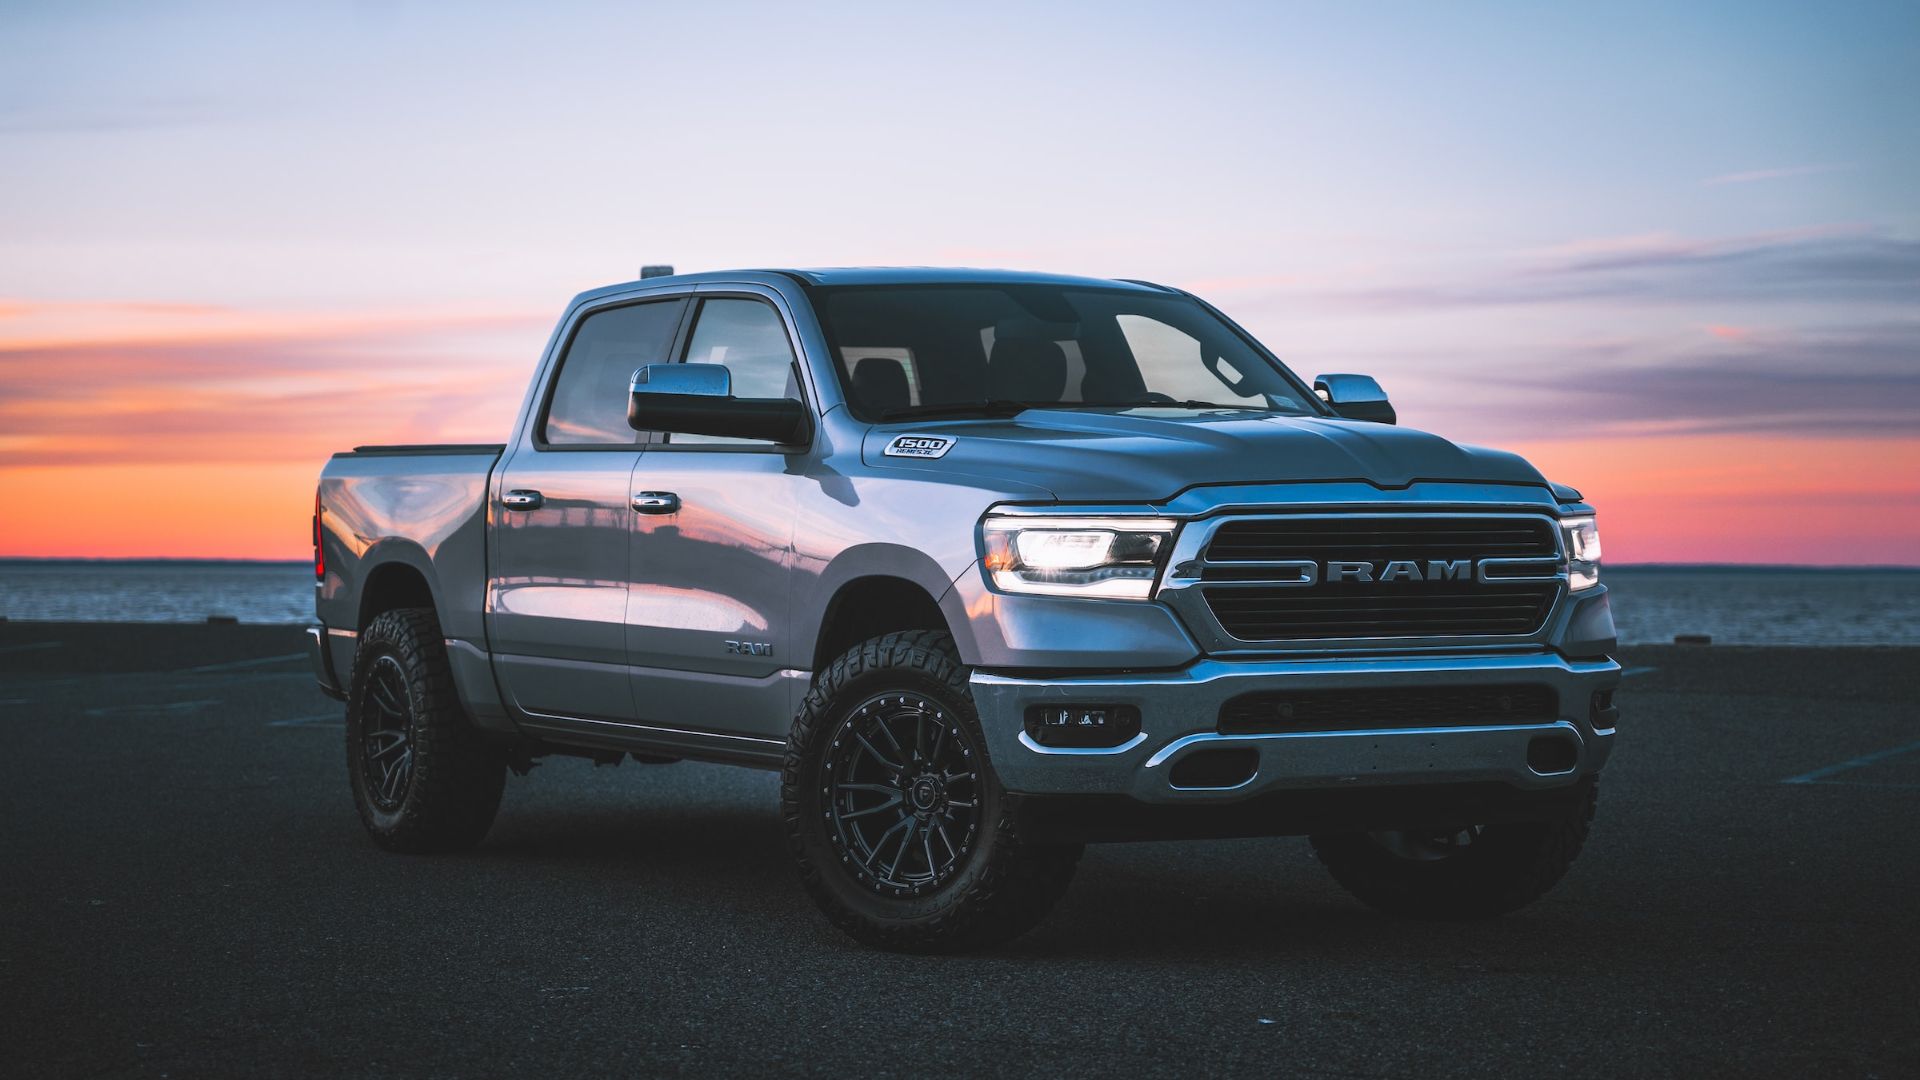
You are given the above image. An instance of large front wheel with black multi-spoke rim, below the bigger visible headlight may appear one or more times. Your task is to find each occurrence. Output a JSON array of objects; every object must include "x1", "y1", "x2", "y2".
[{"x1": 780, "y1": 630, "x2": 1081, "y2": 951}]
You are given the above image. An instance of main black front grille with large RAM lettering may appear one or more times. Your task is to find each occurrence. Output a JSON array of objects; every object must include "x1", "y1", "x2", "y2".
[{"x1": 1200, "y1": 515, "x2": 1561, "y2": 642}]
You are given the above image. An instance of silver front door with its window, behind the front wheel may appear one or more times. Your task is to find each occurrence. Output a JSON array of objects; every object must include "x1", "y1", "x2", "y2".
[{"x1": 626, "y1": 296, "x2": 810, "y2": 742}]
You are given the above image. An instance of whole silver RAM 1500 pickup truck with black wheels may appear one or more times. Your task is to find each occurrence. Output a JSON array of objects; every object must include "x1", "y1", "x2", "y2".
[{"x1": 311, "y1": 269, "x2": 1620, "y2": 951}]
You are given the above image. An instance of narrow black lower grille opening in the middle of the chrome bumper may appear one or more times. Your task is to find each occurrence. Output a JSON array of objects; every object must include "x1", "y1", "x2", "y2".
[{"x1": 1219, "y1": 684, "x2": 1559, "y2": 734}]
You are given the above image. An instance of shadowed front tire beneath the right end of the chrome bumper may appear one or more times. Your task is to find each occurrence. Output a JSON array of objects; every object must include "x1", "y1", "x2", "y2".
[{"x1": 1309, "y1": 778, "x2": 1599, "y2": 920}]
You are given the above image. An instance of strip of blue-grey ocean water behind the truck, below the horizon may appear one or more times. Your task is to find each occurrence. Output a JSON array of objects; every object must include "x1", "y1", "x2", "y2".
[{"x1": 0, "y1": 559, "x2": 1920, "y2": 646}]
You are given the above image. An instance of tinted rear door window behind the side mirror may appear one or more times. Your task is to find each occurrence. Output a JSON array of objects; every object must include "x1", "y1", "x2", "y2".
[{"x1": 541, "y1": 300, "x2": 687, "y2": 446}]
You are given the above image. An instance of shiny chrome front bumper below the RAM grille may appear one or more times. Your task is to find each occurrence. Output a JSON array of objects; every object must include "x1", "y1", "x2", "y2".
[{"x1": 972, "y1": 651, "x2": 1620, "y2": 803}]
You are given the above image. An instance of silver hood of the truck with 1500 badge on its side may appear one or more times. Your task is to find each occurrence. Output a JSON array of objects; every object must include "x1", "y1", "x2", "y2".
[{"x1": 862, "y1": 409, "x2": 1546, "y2": 503}]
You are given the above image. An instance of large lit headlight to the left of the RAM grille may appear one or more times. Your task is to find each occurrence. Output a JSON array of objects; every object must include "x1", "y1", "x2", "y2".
[{"x1": 981, "y1": 515, "x2": 1179, "y2": 600}]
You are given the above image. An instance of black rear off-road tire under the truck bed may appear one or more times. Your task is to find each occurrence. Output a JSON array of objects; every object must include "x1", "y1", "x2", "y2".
[{"x1": 346, "y1": 607, "x2": 507, "y2": 853}]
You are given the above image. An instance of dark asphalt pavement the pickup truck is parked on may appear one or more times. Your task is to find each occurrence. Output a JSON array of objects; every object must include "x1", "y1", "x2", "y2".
[{"x1": 0, "y1": 623, "x2": 1920, "y2": 1078}]
